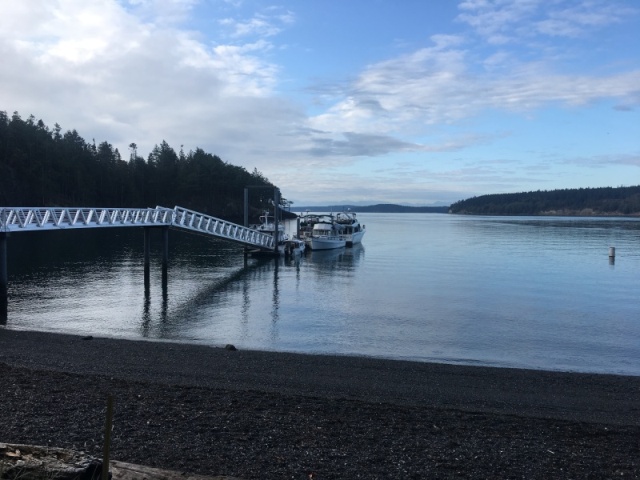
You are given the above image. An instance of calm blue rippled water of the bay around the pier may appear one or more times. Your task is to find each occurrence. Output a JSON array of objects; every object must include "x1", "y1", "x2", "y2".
[{"x1": 2, "y1": 214, "x2": 640, "y2": 375}]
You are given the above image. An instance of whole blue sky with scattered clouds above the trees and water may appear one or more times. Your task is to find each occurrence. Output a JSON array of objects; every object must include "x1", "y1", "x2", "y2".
[{"x1": 0, "y1": 0, "x2": 640, "y2": 206}]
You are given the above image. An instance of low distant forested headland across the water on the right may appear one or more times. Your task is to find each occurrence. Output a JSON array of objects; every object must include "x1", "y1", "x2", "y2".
[{"x1": 449, "y1": 186, "x2": 640, "y2": 215}]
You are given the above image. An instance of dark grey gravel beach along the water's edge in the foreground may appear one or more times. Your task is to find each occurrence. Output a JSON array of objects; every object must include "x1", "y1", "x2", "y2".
[{"x1": 0, "y1": 328, "x2": 640, "y2": 480}]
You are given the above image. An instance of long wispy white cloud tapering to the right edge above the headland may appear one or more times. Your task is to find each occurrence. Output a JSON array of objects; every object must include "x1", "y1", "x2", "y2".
[{"x1": 310, "y1": 35, "x2": 640, "y2": 135}]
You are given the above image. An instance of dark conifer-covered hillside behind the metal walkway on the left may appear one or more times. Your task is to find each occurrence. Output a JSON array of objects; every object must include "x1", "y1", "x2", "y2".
[{"x1": 0, "y1": 111, "x2": 286, "y2": 220}]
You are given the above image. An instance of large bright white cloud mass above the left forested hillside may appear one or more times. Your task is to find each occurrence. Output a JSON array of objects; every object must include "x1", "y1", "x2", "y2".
[{"x1": 0, "y1": 0, "x2": 290, "y2": 158}]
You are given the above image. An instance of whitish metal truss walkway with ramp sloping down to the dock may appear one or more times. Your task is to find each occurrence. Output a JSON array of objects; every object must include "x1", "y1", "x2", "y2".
[{"x1": 0, "y1": 207, "x2": 275, "y2": 250}]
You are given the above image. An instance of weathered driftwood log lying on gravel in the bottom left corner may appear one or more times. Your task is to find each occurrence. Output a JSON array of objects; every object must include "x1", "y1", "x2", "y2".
[{"x1": 0, "y1": 443, "x2": 239, "y2": 480}]
